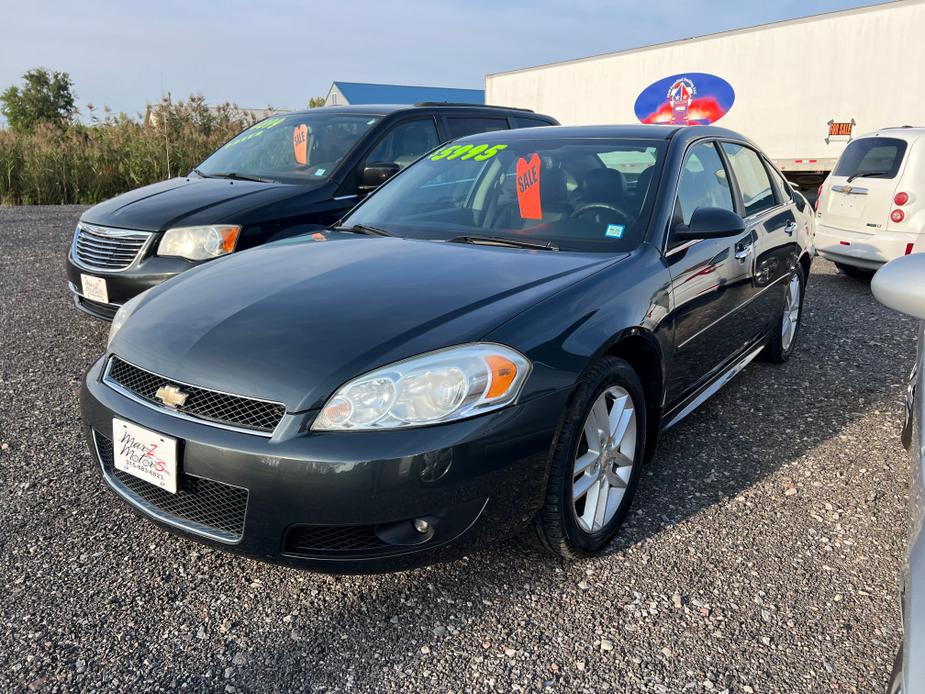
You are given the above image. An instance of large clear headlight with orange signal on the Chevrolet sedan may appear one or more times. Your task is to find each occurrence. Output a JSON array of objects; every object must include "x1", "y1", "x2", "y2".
[{"x1": 312, "y1": 343, "x2": 531, "y2": 431}]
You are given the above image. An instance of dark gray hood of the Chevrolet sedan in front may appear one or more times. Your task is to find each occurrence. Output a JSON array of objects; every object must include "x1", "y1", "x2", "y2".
[{"x1": 112, "y1": 237, "x2": 625, "y2": 412}]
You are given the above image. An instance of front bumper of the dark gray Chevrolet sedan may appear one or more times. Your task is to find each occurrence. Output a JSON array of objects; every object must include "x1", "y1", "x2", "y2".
[{"x1": 81, "y1": 359, "x2": 568, "y2": 573}]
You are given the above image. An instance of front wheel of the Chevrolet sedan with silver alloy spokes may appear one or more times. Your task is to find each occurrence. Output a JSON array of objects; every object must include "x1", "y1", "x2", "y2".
[{"x1": 535, "y1": 357, "x2": 646, "y2": 559}]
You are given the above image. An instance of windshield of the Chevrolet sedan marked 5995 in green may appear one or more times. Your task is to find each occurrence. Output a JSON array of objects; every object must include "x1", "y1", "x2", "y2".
[{"x1": 343, "y1": 134, "x2": 665, "y2": 251}]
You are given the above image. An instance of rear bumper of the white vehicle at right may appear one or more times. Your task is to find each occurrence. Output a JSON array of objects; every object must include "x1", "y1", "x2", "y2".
[{"x1": 815, "y1": 224, "x2": 925, "y2": 270}]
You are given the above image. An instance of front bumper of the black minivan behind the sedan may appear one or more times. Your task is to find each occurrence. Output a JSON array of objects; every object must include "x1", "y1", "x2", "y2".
[{"x1": 66, "y1": 253, "x2": 200, "y2": 320}]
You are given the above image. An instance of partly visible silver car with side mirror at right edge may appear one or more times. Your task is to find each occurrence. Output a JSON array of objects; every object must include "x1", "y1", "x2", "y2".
[{"x1": 871, "y1": 253, "x2": 925, "y2": 694}]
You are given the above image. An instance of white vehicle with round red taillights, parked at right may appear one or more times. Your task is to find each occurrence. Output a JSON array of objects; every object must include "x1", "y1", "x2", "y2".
[{"x1": 815, "y1": 126, "x2": 925, "y2": 276}]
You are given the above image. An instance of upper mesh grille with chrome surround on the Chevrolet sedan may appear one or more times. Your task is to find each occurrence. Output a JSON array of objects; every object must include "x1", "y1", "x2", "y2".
[{"x1": 103, "y1": 355, "x2": 286, "y2": 437}]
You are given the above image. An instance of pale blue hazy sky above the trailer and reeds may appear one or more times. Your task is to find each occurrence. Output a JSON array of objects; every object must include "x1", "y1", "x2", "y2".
[{"x1": 0, "y1": 0, "x2": 896, "y2": 117}]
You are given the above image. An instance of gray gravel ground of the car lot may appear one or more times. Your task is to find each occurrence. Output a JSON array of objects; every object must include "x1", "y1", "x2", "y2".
[{"x1": 0, "y1": 207, "x2": 914, "y2": 694}]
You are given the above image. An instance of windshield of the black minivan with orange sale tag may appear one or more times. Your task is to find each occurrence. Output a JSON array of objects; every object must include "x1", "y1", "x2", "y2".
[{"x1": 196, "y1": 109, "x2": 379, "y2": 183}]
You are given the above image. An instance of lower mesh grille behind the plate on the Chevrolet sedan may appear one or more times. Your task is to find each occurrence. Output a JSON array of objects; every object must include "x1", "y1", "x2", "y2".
[{"x1": 93, "y1": 431, "x2": 248, "y2": 542}]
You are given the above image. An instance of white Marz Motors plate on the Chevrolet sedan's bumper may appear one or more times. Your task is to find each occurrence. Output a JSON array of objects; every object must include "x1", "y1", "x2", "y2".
[{"x1": 112, "y1": 417, "x2": 177, "y2": 494}]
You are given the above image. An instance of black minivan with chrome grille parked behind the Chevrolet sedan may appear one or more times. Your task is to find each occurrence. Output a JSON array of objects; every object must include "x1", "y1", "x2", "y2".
[{"x1": 67, "y1": 103, "x2": 558, "y2": 320}]
